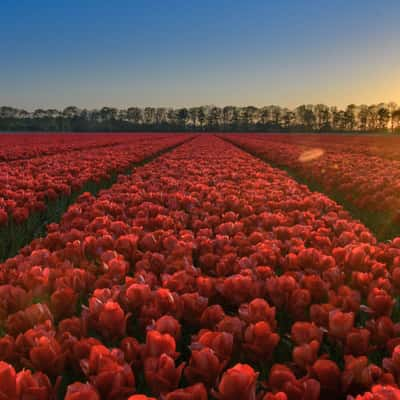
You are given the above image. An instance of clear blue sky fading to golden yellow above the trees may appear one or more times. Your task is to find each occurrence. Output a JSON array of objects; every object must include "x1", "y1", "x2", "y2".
[{"x1": 0, "y1": 0, "x2": 400, "y2": 109}]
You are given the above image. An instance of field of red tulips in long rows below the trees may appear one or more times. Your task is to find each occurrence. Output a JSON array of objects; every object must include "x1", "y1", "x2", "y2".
[{"x1": 0, "y1": 133, "x2": 400, "y2": 400}]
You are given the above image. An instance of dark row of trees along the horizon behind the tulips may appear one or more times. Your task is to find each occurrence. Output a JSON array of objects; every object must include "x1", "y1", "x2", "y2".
[{"x1": 0, "y1": 103, "x2": 400, "y2": 132}]
